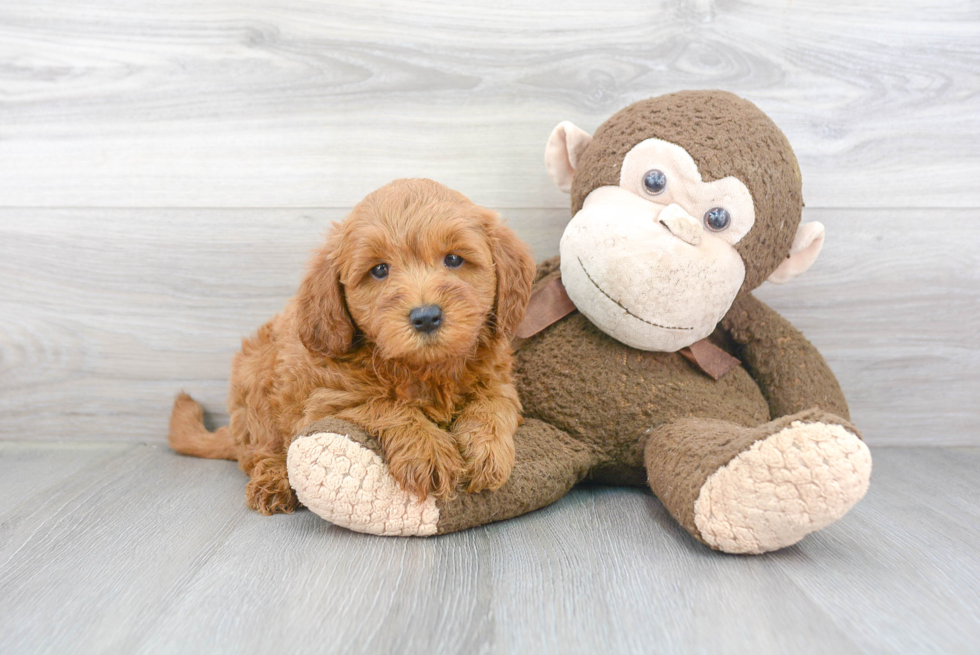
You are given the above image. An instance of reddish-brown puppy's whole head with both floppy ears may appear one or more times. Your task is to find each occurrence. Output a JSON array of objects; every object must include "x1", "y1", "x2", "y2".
[{"x1": 296, "y1": 179, "x2": 535, "y2": 365}]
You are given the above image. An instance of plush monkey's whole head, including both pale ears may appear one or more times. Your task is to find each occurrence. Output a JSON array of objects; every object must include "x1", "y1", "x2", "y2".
[{"x1": 545, "y1": 91, "x2": 824, "y2": 352}]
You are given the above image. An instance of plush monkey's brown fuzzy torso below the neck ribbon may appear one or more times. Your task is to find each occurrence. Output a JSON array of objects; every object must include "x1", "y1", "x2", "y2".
[{"x1": 514, "y1": 312, "x2": 769, "y2": 479}]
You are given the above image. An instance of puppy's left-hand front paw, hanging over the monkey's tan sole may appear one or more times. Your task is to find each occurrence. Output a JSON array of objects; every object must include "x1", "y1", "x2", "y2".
[{"x1": 385, "y1": 434, "x2": 466, "y2": 500}]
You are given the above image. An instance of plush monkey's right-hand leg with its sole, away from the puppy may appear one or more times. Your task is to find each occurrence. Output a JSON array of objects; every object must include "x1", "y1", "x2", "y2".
[{"x1": 644, "y1": 410, "x2": 871, "y2": 553}]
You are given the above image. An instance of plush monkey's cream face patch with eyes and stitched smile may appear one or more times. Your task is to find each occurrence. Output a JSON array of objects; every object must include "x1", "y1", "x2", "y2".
[{"x1": 560, "y1": 139, "x2": 755, "y2": 352}]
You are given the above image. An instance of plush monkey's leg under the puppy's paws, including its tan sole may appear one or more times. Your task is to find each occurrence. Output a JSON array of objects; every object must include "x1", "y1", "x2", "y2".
[{"x1": 280, "y1": 418, "x2": 595, "y2": 536}]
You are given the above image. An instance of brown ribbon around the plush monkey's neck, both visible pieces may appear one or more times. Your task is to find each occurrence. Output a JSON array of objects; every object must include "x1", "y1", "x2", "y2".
[{"x1": 517, "y1": 277, "x2": 742, "y2": 380}]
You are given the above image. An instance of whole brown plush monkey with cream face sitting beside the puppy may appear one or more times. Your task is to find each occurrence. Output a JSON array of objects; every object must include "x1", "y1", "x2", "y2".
[{"x1": 289, "y1": 92, "x2": 871, "y2": 553}]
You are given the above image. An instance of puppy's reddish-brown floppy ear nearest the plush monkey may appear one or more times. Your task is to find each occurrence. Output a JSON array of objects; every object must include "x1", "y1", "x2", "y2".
[{"x1": 487, "y1": 212, "x2": 535, "y2": 337}]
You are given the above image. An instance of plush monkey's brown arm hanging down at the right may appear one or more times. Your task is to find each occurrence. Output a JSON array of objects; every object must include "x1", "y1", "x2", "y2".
[{"x1": 721, "y1": 294, "x2": 850, "y2": 420}]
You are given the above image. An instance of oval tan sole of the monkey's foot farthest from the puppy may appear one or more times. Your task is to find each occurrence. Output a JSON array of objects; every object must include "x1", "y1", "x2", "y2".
[{"x1": 694, "y1": 421, "x2": 871, "y2": 553}]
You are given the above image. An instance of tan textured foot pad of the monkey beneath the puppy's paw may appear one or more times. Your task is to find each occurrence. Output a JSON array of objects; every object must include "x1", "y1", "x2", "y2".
[{"x1": 286, "y1": 432, "x2": 439, "y2": 537}]
